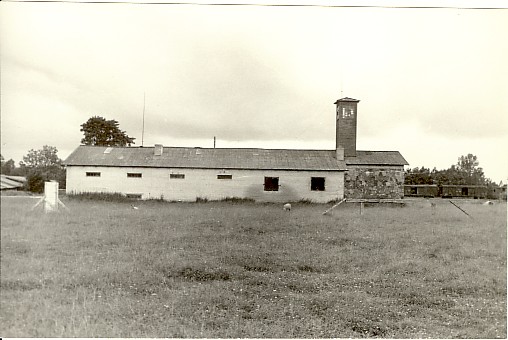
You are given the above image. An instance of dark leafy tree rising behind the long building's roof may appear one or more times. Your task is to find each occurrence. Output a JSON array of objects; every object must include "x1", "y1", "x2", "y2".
[{"x1": 79, "y1": 116, "x2": 136, "y2": 146}]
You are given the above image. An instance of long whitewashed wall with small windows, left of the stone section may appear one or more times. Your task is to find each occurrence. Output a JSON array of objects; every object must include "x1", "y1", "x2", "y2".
[{"x1": 66, "y1": 166, "x2": 344, "y2": 203}]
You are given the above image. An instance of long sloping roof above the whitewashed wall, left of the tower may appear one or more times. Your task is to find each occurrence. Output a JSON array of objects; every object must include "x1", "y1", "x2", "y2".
[{"x1": 64, "y1": 145, "x2": 346, "y2": 171}]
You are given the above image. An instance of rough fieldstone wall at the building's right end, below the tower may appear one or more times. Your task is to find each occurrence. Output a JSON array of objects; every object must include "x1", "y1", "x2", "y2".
[{"x1": 344, "y1": 165, "x2": 404, "y2": 199}]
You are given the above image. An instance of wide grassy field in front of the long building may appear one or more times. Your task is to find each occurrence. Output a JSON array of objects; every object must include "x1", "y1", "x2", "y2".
[{"x1": 0, "y1": 197, "x2": 507, "y2": 338}]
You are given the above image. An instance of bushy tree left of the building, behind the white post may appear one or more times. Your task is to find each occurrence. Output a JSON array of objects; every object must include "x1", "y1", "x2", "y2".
[{"x1": 19, "y1": 145, "x2": 65, "y2": 192}]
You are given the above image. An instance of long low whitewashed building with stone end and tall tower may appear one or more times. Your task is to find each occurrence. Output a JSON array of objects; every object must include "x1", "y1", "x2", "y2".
[{"x1": 64, "y1": 98, "x2": 408, "y2": 203}]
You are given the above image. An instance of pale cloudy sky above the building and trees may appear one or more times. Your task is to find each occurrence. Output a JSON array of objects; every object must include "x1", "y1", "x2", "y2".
[{"x1": 0, "y1": 0, "x2": 508, "y2": 183}]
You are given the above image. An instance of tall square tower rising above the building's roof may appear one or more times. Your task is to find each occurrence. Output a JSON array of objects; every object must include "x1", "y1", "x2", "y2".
[{"x1": 334, "y1": 97, "x2": 359, "y2": 160}]
